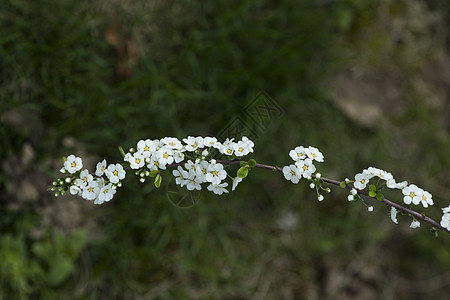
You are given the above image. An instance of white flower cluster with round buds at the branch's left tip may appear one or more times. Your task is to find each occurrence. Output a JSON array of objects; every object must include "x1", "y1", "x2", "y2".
[{"x1": 52, "y1": 154, "x2": 126, "y2": 204}]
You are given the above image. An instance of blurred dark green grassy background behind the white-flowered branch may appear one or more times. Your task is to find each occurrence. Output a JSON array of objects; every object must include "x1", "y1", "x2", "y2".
[{"x1": 0, "y1": 0, "x2": 450, "y2": 299}]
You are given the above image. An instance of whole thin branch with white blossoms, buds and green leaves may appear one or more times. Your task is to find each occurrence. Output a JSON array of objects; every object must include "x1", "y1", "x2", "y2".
[{"x1": 51, "y1": 136, "x2": 450, "y2": 233}]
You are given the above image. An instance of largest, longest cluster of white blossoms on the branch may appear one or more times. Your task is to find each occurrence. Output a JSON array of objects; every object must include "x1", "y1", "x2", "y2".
[{"x1": 124, "y1": 136, "x2": 254, "y2": 195}]
